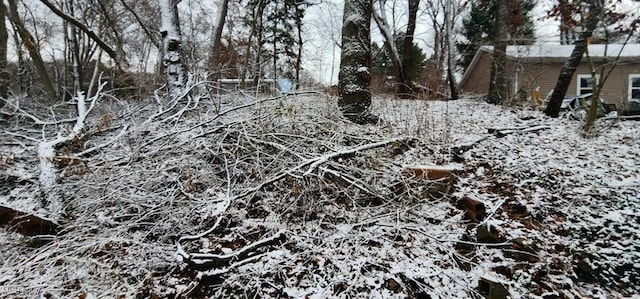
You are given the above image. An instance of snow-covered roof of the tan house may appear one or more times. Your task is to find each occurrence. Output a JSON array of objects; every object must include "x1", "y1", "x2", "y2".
[{"x1": 460, "y1": 44, "x2": 640, "y2": 86}]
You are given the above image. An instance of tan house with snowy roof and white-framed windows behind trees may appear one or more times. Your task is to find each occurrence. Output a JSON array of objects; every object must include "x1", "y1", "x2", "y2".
[{"x1": 460, "y1": 44, "x2": 640, "y2": 111}]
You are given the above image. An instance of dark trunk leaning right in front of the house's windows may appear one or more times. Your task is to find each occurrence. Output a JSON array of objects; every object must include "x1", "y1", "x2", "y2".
[{"x1": 544, "y1": 0, "x2": 602, "y2": 117}]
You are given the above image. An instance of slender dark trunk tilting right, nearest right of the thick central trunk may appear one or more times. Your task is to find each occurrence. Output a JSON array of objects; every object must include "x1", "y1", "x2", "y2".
[{"x1": 398, "y1": 0, "x2": 420, "y2": 99}]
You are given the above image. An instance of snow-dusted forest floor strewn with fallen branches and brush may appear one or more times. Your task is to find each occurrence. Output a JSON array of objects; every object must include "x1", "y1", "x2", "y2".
[{"x1": 0, "y1": 93, "x2": 640, "y2": 298}]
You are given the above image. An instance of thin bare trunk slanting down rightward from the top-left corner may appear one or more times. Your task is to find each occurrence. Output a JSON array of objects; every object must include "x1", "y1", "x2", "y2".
[{"x1": 0, "y1": 0, "x2": 58, "y2": 102}]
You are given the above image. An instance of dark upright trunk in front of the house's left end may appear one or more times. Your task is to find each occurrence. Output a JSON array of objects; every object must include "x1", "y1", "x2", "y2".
[{"x1": 487, "y1": 0, "x2": 509, "y2": 104}]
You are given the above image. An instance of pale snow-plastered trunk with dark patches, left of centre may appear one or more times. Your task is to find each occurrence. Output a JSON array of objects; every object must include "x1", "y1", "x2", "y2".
[{"x1": 160, "y1": 0, "x2": 187, "y2": 98}]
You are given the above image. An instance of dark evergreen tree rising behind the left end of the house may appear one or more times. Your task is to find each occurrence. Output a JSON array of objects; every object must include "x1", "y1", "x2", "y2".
[{"x1": 457, "y1": 0, "x2": 536, "y2": 70}]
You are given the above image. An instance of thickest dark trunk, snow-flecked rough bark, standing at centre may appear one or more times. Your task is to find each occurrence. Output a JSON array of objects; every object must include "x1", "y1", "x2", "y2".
[{"x1": 338, "y1": 0, "x2": 372, "y2": 123}]
